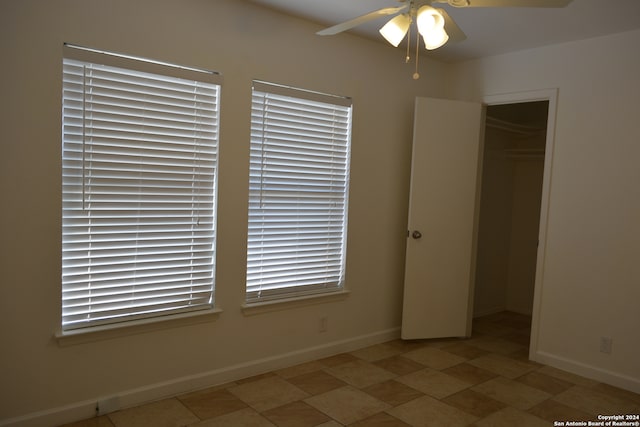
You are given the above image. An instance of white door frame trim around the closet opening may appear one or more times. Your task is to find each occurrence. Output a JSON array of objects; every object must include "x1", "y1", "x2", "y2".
[{"x1": 482, "y1": 88, "x2": 558, "y2": 361}]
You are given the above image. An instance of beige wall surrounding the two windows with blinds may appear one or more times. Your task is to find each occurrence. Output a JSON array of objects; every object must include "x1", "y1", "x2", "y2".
[{"x1": 0, "y1": 0, "x2": 447, "y2": 425}]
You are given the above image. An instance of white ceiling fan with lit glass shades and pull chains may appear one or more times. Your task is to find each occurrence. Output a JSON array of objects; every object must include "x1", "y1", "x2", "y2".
[{"x1": 316, "y1": 0, "x2": 572, "y2": 79}]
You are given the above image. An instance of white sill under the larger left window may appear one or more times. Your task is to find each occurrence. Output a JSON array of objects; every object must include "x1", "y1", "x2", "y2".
[{"x1": 55, "y1": 308, "x2": 222, "y2": 347}]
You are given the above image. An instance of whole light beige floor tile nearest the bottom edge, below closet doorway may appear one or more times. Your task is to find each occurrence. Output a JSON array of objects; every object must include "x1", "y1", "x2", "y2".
[{"x1": 472, "y1": 377, "x2": 551, "y2": 411}]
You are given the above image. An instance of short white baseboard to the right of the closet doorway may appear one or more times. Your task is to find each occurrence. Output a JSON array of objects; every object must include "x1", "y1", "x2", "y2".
[{"x1": 532, "y1": 351, "x2": 640, "y2": 393}]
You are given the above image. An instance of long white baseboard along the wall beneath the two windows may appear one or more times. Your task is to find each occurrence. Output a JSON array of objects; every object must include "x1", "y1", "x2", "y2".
[{"x1": 0, "y1": 328, "x2": 400, "y2": 427}]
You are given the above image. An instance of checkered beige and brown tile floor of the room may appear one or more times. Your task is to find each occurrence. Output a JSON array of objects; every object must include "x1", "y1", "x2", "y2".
[{"x1": 61, "y1": 312, "x2": 640, "y2": 427}]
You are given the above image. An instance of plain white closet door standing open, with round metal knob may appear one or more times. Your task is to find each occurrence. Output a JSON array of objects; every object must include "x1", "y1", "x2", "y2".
[{"x1": 402, "y1": 98, "x2": 484, "y2": 339}]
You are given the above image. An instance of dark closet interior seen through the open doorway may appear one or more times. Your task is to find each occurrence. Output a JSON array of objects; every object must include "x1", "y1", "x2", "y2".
[{"x1": 474, "y1": 100, "x2": 549, "y2": 317}]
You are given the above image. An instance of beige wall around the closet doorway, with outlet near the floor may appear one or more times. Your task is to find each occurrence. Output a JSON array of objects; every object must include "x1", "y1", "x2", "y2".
[{"x1": 454, "y1": 31, "x2": 640, "y2": 392}]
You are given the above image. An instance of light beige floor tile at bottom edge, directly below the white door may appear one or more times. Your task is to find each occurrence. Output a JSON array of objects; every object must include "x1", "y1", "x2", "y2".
[{"x1": 387, "y1": 396, "x2": 478, "y2": 427}]
